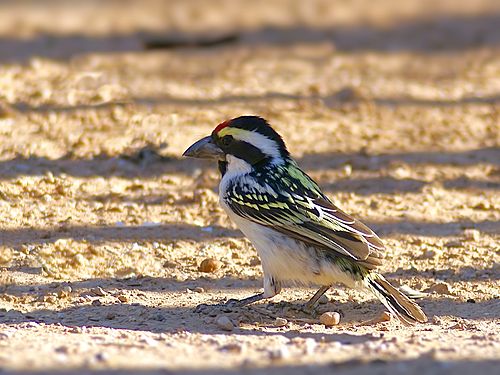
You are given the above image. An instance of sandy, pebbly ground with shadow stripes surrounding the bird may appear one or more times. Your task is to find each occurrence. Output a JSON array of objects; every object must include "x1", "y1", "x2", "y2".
[{"x1": 0, "y1": 0, "x2": 500, "y2": 375}]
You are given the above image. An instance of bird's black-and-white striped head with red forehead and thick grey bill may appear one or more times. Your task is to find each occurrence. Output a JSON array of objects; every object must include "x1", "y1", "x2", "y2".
[{"x1": 182, "y1": 116, "x2": 289, "y2": 166}]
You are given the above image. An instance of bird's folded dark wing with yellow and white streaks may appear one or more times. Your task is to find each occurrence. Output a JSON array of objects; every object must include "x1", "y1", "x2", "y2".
[{"x1": 223, "y1": 168, "x2": 384, "y2": 268}]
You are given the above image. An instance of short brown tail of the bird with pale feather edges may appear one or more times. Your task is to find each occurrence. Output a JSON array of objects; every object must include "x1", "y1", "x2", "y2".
[{"x1": 365, "y1": 272, "x2": 427, "y2": 325}]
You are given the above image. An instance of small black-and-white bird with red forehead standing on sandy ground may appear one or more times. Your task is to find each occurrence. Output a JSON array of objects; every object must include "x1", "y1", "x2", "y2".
[{"x1": 183, "y1": 115, "x2": 427, "y2": 325}]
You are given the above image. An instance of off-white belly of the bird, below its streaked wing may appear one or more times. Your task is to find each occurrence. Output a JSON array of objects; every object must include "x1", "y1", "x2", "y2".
[{"x1": 220, "y1": 199, "x2": 356, "y2": 287}]
